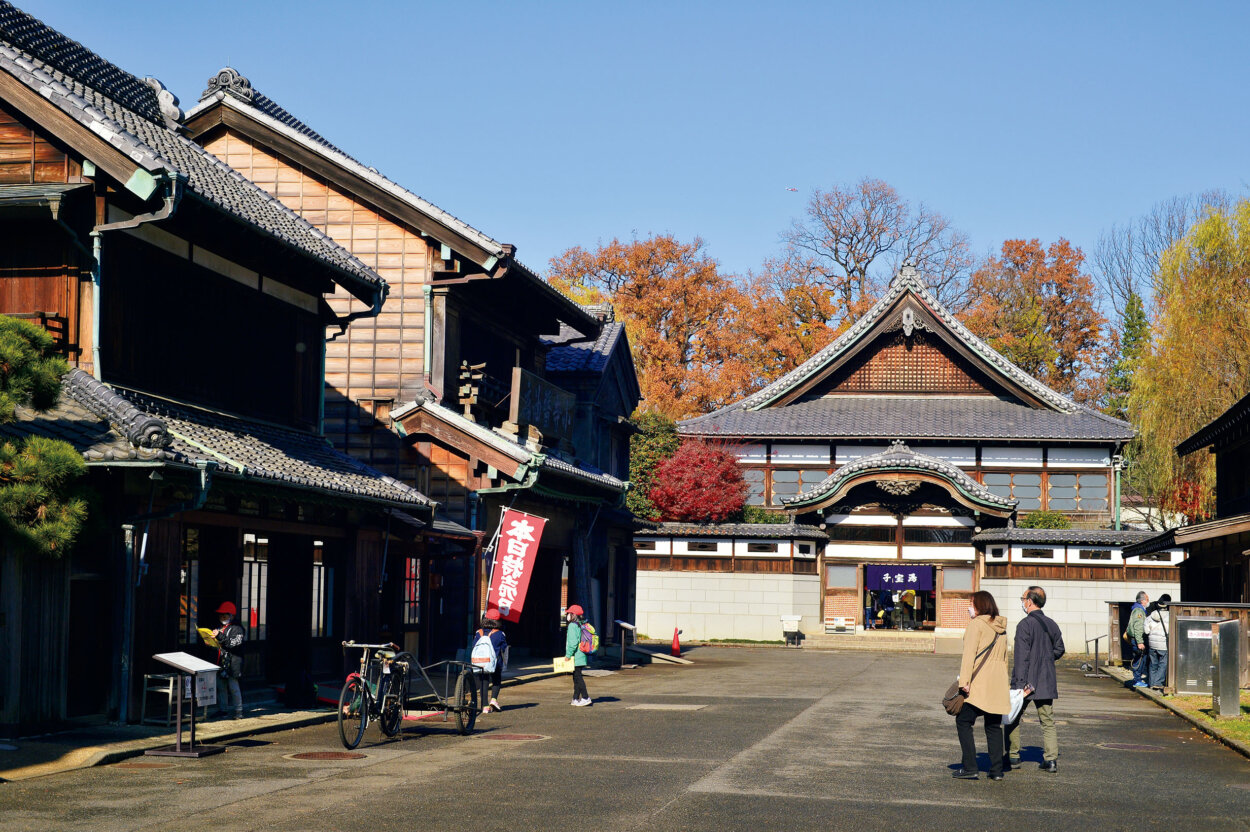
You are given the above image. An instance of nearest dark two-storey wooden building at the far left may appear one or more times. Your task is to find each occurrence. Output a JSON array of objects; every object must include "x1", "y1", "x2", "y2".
[{"x1": 0, "y1": 2, "x2": 440, "y2": 731}]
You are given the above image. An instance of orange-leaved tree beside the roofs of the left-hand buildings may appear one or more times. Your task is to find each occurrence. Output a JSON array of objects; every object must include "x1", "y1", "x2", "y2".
[{"x1": 550, "y1": 235, "x2": 763, "y2": 418}]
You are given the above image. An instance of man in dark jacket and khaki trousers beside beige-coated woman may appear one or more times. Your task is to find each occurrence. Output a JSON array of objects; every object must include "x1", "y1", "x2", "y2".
[{"x1": 1006, "y1": 586, "x2": 1065, "y2": 772}]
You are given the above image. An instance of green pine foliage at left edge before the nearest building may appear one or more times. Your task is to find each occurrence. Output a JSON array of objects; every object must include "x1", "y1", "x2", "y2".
[{"x1": 0, "y1": 315, "x2": 86, "y2": 557}]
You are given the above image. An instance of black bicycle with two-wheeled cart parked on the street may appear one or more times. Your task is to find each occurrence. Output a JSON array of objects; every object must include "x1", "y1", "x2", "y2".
[{"x1": 339, "y1": 641, "x2": 480, "y2": 748}]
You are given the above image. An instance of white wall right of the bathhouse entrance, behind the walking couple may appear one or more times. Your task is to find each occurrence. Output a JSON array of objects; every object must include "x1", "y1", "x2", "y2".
[{"x1": 981, "y1": 578, "x2": 1181, "y2": 656}]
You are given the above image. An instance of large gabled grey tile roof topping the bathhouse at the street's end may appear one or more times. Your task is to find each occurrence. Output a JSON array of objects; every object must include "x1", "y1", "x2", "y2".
[{"x1": 680, "y1": 266, "x2": 1135, "y2": 440}]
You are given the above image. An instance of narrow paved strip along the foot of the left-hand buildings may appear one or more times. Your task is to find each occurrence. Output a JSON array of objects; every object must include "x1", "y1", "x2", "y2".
[{"x1": 0, "y1": 660, "x2": 554, "y2": 781}]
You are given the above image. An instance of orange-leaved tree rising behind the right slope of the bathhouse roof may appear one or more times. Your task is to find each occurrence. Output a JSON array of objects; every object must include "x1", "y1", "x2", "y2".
[{"x1": 963, "y1": 239, "x2": 1106, "y2": 401}]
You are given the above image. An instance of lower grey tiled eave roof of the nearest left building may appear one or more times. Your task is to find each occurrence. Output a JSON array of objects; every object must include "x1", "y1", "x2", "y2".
[{"x1": 0, "y1": 370, "x2": 431, "y2": 507}]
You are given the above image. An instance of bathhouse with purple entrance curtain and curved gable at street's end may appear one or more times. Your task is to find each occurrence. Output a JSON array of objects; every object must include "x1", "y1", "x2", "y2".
[{"x1": 639, "y1": 266, "x2": 1179, "y2": 646}]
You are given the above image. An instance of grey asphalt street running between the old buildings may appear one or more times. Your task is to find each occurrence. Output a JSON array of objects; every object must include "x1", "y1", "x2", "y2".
[{"x1": 0, "y1": 647, "x2": 1250, "y2": 832}]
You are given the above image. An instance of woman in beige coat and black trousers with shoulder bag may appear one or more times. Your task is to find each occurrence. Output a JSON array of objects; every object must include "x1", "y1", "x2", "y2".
[{"x1": 954, "y1": 591, "x2": 1011, "y2": 780}]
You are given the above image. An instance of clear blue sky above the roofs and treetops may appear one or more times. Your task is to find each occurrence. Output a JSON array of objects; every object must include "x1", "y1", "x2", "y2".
[{"x1": 18, "y1": 0, "x2": 1250, "y2": 279}]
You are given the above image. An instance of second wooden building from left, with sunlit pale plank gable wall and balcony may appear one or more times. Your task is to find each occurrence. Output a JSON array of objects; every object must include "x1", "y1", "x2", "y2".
[{"x1": 184, "y1": 67, "x2": 639, "y2": 655}]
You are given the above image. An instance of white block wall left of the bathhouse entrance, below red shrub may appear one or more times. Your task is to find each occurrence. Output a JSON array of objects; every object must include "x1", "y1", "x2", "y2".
[{"x1": 635, "y1": 571, "x2": 824, "y2": 641}]
